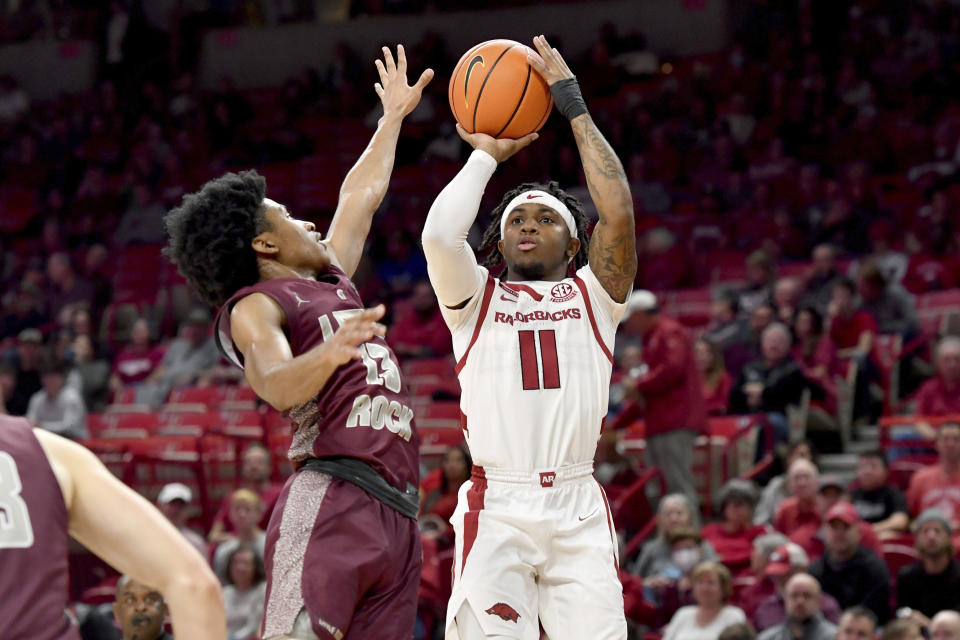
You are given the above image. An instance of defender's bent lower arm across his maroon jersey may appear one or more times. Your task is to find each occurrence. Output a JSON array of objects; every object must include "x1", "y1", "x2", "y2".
[{"x1": 230, "y1": 293, "x2": 387, "y2": 411}]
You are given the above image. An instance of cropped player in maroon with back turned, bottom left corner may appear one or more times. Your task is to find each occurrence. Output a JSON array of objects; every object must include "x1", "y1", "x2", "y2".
[{"x1": 0, "y1": 416, "x2": 227, "y2": 640}]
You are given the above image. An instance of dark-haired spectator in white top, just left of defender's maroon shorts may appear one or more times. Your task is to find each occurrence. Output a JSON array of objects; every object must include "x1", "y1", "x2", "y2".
[{"x1": 223, "y1": 547, "x2": 267, "y2": 640}]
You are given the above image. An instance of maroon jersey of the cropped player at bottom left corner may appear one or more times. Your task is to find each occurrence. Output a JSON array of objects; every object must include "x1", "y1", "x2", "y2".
[{"x1": 0, "y1": 416, "x2": 80, "y2": 640}]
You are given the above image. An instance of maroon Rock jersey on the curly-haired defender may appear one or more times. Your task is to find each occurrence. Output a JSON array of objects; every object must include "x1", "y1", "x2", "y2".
[{"x1": 215, "y1": 265, "x2": 420, "y2": 491}]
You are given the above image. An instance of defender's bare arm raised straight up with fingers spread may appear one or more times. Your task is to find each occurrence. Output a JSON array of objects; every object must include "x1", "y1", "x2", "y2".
[{"x1": 326, "y1": 45, "x2": 433, "y2": 276}]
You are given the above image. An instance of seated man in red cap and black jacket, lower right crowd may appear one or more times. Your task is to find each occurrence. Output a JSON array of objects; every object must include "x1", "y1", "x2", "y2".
[{"x1": 810, "y1": 502, "x2": 890, "y2": 623}]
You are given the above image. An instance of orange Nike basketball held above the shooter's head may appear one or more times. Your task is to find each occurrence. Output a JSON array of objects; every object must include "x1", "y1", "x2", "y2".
[{"x1": 448, "y1": 40, "x2": 553, "y2": 138}]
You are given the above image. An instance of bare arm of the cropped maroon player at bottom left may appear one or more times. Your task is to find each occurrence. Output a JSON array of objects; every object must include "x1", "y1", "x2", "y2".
[{"x1": 34, "y1": 429, "x2": 227, "y2": 640}]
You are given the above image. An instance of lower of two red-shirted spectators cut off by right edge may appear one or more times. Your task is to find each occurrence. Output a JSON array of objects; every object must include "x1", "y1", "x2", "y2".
[{"x1": 907, "y1": 422, "x2": 960, "y2": 530}]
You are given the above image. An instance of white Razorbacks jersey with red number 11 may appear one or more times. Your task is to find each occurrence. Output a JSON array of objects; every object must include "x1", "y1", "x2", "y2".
[{"x1": 441, "y1": 266, "x2": 626, "y2": 471}]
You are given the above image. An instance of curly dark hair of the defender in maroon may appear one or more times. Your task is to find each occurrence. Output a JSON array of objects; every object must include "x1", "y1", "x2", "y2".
[{"x1": 163, "y1": 171, "x2": 270, "y2": 307}]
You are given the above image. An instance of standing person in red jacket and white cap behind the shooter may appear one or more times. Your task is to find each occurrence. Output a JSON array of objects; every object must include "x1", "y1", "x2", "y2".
[{"x1": 622, "y1": 290, "x2": 707, "y2": 504}]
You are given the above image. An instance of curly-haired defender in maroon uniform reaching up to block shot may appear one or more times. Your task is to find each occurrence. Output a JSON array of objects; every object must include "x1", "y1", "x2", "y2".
[{"x1": 166, "y1": 46, "x2": 433, "y2": 640}]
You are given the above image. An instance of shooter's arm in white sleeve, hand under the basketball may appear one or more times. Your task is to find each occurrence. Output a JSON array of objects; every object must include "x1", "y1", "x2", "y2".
[{"x1": 422, "y1": 124, "x2": 537, "y2": 309}]
